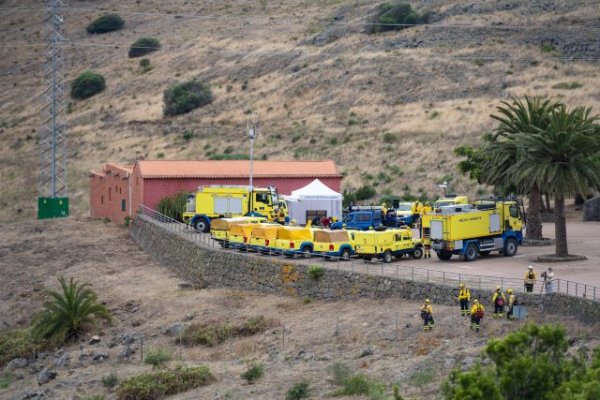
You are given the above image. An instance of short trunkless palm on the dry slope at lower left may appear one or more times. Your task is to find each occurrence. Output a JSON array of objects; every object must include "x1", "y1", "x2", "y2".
[{"x1": 32, "y1": 276, "x2": 111, "y2": 342}]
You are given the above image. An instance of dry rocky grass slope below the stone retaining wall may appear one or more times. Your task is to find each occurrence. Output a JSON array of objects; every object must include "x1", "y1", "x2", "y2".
[{"x1": 0, "y1": 219, "x2": 600, "y2": 400}]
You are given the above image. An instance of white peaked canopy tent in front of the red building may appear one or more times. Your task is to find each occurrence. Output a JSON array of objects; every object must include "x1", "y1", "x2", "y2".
[{"x1": 283, "y1": 179, "x2": 343, "y2": 225}]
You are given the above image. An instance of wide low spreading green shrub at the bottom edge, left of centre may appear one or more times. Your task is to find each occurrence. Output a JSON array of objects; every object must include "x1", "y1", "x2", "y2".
[{"x1": 117, "y1": 367, "x2": 215, "y2": 400}]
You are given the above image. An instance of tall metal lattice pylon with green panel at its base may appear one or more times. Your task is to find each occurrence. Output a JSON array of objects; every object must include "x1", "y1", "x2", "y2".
[{"x1": 38, "y1": 0, "x2": 69, "y2": 219}]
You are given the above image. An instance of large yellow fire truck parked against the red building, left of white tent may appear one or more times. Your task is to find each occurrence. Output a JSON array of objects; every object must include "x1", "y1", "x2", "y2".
[{"x1": 183, "y1": 185, "x2": 289, "y2": 232}]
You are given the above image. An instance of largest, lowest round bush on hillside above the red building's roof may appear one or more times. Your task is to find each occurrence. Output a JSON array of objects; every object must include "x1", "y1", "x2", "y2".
[{"x1": 163, "y1": 80, "x2": 213, "y2": 116}]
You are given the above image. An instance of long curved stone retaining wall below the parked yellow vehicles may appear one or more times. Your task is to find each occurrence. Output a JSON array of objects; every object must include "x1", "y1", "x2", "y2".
[{"x1": 131, "y1": 217, "x2": 600, "y2": 323}]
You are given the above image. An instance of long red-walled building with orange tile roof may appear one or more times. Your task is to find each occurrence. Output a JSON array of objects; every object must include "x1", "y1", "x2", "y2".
[{"x1": 90, "y1": 160, "x2": 342, "y2": 223}]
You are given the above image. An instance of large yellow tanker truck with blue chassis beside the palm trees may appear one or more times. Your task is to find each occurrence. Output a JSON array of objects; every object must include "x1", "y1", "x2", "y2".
[{"x1": 423, "y1": 200, "x2": 524, "y2": 261}]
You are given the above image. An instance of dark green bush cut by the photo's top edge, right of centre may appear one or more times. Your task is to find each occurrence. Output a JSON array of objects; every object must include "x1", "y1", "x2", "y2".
[{"x1": 368, "y1": 2, "x2": 429, "y2": 33}]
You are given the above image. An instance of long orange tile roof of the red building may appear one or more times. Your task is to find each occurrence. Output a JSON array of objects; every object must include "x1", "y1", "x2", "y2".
[{"x1": 134, "y1": 160, "x2": 342, "y2": 178}]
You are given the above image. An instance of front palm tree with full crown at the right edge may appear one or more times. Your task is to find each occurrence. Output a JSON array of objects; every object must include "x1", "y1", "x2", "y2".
[{"x1": 511, "y1": 106, "x2": 600, "y2": 257}]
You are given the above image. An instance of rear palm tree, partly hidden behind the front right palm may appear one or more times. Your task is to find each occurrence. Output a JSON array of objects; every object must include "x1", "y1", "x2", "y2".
[{"x1": 482, "y1": 96, "x2": 562, "y2": 240}]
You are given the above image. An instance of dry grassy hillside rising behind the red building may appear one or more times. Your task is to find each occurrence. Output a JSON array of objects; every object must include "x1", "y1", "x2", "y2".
[{"x1": 0, "y1": 0, "x2": 600, "y2": 221}]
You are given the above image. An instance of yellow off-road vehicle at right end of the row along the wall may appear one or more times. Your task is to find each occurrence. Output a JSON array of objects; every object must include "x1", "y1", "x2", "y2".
[{"x1": 354, "y1": 229, "x2": 423, "y2": 263}]
